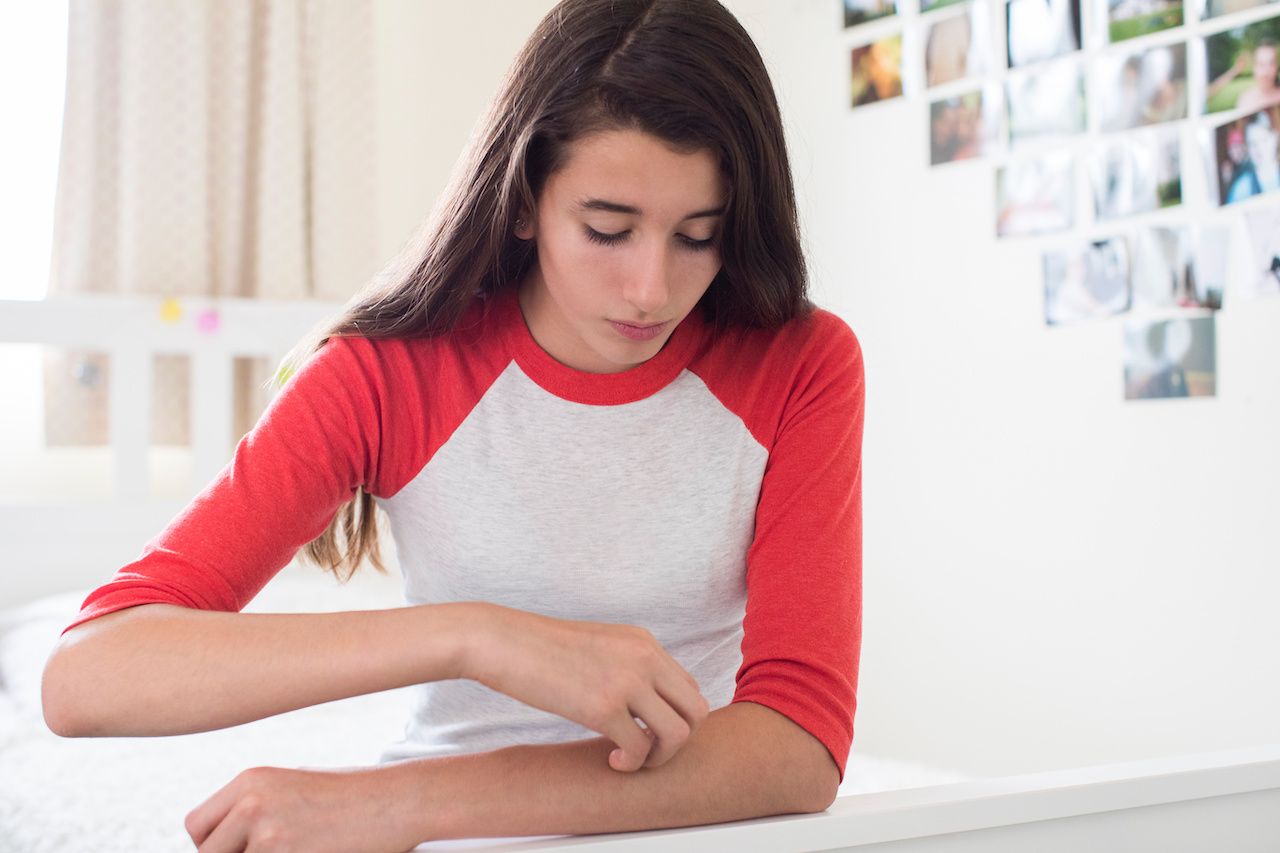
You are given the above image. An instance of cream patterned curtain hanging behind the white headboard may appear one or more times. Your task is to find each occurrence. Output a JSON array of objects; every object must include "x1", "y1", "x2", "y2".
[{"x1": 45, "y1": 0, "x2": 378, "y2": 446}]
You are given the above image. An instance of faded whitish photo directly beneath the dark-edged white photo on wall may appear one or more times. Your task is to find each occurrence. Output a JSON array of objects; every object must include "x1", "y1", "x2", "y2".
[{"x1": 1005, "y1": 58, "x2": 1084, "y2": 146}]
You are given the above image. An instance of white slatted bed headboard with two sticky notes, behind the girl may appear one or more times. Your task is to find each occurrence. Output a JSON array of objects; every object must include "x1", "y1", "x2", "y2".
[{"x1": 0, "y1": 295, "x2": 342, "y2": 607}]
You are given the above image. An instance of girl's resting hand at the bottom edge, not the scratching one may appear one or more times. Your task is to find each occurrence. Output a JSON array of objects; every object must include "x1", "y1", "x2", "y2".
[{"x1": 186, "y1": 767, "x2": 424, "y2": 853}]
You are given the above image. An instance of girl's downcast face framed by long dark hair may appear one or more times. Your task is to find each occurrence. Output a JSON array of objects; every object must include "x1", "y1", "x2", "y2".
[{"x1": 516, "y1": 129, "x2": 727, "y2": 373}]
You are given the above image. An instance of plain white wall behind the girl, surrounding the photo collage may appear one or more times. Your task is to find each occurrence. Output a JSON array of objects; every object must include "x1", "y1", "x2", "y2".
[{"x1": 379, "y1": 0, "x2": 1280, "y2": 774}]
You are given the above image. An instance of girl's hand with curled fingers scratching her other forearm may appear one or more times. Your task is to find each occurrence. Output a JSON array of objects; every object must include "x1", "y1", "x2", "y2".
[{"x1": 462, "y1": 605, "x2": 710, "y2": 772}]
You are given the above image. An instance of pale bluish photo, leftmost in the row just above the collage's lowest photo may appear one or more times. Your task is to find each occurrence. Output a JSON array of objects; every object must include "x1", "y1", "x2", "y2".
[{"x1": 1043, "y1": 237, "x2": 1133, "y2": 325}]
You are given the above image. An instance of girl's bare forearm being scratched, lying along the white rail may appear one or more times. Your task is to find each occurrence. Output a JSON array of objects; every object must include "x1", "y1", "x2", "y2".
[{"x1": 380, "y1": 702, "x2": 838, "y2": 840}]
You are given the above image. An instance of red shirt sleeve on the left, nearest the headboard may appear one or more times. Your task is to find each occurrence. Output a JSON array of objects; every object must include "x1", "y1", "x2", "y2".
[{"x1": 63, "y1": 338, "x2": 381, "y2": 634}]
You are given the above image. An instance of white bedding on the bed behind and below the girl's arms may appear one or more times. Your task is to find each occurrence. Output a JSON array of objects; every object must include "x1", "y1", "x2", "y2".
[{"x1": 0, "y1": 566, "x2": 963, "y2": 853}]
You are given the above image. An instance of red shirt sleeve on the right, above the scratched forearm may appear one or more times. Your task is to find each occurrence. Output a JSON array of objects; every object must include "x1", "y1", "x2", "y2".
[{"x1": 732, "y1": 315, "x2": 864, "y2": 781}]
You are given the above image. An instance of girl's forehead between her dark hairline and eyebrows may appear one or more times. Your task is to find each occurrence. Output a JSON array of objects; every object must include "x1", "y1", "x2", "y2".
[{"x1": 545, "y1": 131, "x2": 726, "y2": 219}]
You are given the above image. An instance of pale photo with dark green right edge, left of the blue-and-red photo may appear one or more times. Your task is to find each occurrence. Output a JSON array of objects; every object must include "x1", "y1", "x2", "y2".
[{"x1": 1088, "y1": 128, "x2": 1183, "y2": 219}]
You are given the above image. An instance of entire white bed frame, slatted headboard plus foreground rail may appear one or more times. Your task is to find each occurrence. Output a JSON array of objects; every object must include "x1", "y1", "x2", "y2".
[{"x1": 0, "y1": 296, "x2": 1280, "y2": 853}]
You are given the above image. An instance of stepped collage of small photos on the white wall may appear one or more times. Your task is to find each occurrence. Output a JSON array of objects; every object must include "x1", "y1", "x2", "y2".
[{"x1": 842, "y1": 0, "x2": 1280, "y2": 400}]
